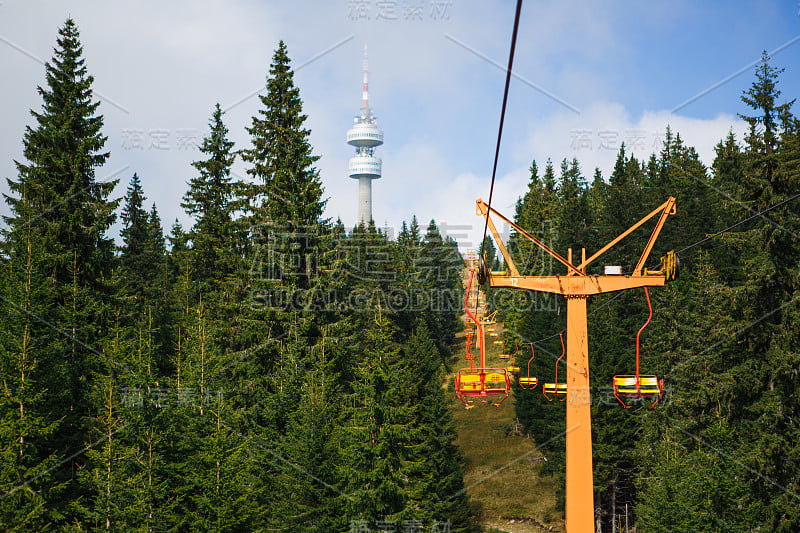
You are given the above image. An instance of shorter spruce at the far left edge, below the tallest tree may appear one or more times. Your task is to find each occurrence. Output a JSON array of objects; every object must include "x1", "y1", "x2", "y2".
[{"x1": 0, "y1": 196, "x2": 60, "y2": 530}]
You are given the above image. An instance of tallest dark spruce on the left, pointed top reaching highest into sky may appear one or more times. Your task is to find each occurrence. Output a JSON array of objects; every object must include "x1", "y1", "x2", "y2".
[{"x1": 1, "y1": 19, "x2": 118, "y2": 522}]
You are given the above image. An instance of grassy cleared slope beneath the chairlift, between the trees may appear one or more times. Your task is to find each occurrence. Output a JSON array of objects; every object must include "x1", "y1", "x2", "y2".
[{"x1": 448, "y1": 324, "x2": 564, "y2": 533}]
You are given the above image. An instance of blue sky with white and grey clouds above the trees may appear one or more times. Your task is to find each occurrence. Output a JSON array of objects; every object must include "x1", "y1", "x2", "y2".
[{"x1": 0, "y1": 0, "x2": 800, "y2": 247}]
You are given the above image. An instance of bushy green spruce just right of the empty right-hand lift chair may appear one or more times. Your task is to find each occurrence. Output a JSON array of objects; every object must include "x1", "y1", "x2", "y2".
[{"x1": 635, "y1": 254, "x2": 759, "y2": 531}]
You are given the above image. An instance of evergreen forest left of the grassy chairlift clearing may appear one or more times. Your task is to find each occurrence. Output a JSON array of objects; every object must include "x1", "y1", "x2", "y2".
[{"x1": 0, "y1": 19, "x2": 475, "y2": 532}]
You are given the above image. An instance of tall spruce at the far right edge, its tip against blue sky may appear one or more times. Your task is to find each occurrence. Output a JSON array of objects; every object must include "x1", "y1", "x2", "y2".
[{"x1": 731, "y1": 54, "x2": 800, "y2": 530}]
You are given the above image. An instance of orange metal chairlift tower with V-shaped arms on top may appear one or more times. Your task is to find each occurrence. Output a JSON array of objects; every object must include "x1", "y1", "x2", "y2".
[{"x1": 476, "y1": 197, "x2": 677, "y2": 533}]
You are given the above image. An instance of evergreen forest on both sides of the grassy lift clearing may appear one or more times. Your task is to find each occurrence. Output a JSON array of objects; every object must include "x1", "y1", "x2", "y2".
[{"x1": 0, "y1": 19, "x2": 800, "y2": 533}]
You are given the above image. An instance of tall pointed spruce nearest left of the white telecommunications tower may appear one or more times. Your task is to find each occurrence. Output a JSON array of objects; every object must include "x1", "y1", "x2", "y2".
[{"x1": 230, "y1": 38, "x2": 348, "y2": 528}]
